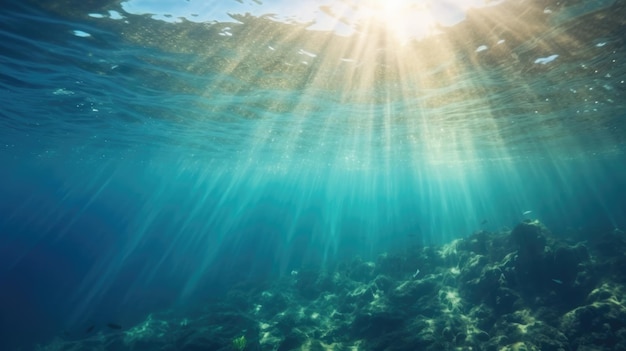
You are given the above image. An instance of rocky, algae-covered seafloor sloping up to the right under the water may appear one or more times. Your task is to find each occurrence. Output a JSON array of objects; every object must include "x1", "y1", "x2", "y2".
[{"x1": 38, "y1": 221, "x2": 626, "y2": 351}]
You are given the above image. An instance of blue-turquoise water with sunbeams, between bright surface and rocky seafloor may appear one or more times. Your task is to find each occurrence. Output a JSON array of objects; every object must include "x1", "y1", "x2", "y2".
[{"x1": 0, "y1": 1, "x2": 626, "y2": 350}]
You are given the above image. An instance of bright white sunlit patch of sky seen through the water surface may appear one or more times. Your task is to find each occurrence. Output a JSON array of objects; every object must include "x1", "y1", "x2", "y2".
[{"x1": 122, "y1": 0, "x2": 502, "y2": 42}]
